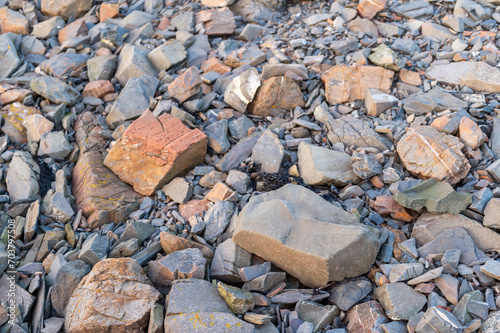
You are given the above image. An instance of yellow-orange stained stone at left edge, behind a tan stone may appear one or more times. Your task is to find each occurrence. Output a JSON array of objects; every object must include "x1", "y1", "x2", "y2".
[{"x1": 0, "y1": 103, "x2": 42, "y2": 143}]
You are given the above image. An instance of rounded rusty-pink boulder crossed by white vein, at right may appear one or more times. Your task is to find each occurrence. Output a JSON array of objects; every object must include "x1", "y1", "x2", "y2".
[{"x1": 397, "y1": 126, "x2": 470, "y2": 185}]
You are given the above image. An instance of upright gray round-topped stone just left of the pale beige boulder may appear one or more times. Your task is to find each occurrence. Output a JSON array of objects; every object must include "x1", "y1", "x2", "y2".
[{"x1": 251, "y1": 131, "x2": 285, "y2": 173}]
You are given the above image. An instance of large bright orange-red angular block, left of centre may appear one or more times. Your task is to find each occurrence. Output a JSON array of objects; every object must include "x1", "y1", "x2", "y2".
[{"x1": 104, "y1": 110, "x2": 207, "y2": 196}]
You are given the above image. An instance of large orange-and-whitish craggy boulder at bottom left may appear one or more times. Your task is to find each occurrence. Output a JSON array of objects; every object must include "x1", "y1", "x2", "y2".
[{"x1": 64, "y1": 258, "x2": 160, "y2": 333}]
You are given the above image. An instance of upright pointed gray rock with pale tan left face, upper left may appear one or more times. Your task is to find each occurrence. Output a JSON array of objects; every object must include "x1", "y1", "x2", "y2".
[{"x1": 115, "y1": 44, "x2": 158, "y2": 86}]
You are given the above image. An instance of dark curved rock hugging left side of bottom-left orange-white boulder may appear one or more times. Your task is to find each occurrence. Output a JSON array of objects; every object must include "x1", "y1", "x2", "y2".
[{"x1": 50, "y1": 260, "x2": 90, "y2": 317}]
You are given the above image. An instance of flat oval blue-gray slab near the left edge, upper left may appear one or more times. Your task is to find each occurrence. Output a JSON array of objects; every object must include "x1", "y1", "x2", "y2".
[{"x1": 30, "y1": 76, "x2": 81, "y2": 106}]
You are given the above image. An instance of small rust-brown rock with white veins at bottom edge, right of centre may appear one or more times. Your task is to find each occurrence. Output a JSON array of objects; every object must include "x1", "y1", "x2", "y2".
[{"x1": 346, "y1": 301, "x2": 389, "y2": 333}]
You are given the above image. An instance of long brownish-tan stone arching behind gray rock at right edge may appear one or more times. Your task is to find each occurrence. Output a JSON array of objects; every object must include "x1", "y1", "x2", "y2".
[{"x1": 412, "y1": 213, "x2": 500, "y2": 253}]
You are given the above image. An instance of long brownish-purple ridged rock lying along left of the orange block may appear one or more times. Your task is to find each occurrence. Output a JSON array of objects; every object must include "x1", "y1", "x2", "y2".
[{"x1": 71, "y1": 112, "x2": 141, "y2": 228}]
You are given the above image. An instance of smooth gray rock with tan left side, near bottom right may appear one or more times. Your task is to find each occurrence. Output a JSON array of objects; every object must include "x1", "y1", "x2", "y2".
[{"x1": 374, "y1": 282, "x2": 427, "y2": 320}]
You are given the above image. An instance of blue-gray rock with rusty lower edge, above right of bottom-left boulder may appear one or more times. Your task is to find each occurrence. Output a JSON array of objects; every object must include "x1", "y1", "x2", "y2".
[{"x1": 148, "y1": 248, "x2": 206, "y2": 286}]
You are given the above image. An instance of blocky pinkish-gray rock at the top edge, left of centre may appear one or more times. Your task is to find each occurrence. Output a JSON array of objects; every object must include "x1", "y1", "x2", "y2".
[{"x1": 196, "y1": 7, "x2": 236, "y2": 36}]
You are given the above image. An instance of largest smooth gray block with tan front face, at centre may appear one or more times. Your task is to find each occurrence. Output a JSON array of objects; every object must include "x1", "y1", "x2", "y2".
[{"x1": 234, "y1": 184, "x2": 378, "y2": 287}]
